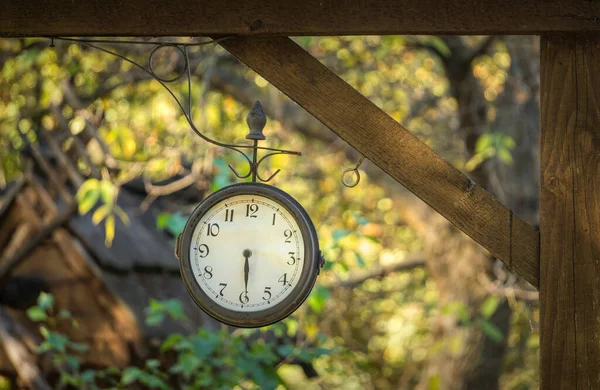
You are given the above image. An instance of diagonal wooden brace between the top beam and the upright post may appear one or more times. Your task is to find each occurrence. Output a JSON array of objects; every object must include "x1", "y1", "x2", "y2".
[{"x1": 221, "y1": 37, "x2": 539, "y2": 287}]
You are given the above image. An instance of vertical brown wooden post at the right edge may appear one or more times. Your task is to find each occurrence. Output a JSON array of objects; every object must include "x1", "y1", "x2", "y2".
[{"x1": 540, "y1": 34, "x2": 600, "y2": 389}]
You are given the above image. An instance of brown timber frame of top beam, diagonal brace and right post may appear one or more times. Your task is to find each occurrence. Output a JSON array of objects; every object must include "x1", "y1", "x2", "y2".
[{"x1": 0, "y1": 0, "x2": 600, "y2": 389}]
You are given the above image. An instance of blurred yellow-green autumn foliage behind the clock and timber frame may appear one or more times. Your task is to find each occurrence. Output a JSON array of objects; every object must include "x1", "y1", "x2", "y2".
[{"x1": 0, "y1": 36, "x2": 539, "y2": 390}]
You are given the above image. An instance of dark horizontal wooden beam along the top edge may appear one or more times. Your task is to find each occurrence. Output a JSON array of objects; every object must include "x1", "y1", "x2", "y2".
[{"x1": 0, "y1": 0, "x2": 600, "y2": 37}]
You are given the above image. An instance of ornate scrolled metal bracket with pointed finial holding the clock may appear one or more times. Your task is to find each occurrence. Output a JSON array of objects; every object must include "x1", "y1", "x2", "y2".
[{"x1": 48, "y1": 37, "x2": 302, "y2": 182}]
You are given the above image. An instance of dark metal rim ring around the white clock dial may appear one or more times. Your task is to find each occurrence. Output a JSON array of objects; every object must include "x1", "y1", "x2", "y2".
[{"x1": 177, "y1": 183, "x2": 321, "y2": 328}]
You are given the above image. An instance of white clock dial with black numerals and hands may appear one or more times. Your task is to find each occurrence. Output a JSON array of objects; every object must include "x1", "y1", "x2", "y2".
[{"x1": 189, "y1": 194, "x2": 305, "y2": 312}]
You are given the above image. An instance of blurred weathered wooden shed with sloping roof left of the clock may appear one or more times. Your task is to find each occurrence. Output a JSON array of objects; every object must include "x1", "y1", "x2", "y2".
[{"x1": 0, "y1": 110, "x2": 210, "y2": 382}]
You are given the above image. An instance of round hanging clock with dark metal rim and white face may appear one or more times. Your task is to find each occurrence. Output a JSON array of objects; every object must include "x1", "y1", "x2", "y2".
[{"x1": 177, "y1": 183, "x2": 322, "y2": 328}]
